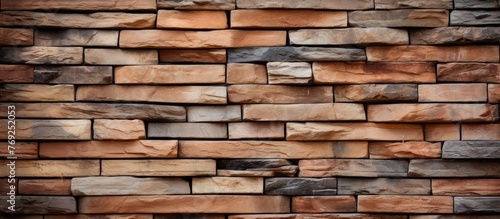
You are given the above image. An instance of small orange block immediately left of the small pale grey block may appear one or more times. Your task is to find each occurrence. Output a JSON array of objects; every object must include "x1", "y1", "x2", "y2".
[{"x1": 226, "y1": 63, "x2": 267, "y2": 84}]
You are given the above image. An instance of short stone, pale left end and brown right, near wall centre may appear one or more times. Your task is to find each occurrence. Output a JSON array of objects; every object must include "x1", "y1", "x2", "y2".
[{"x1": 228, "y1": 122, "x2": 285, "y2": 139}]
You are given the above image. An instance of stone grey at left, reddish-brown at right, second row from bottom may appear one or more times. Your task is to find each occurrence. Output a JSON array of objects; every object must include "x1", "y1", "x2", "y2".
[{"x1": 337, "y1": 178, "x2": 431, "y2": 195}]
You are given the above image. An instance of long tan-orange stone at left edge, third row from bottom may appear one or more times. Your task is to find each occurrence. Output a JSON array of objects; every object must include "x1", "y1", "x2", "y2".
[{"x1": 0, "y1": 160, "x2": 100, "y2": 177}]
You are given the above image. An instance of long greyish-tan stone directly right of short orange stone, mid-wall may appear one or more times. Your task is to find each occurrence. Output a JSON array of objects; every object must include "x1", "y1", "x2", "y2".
[{"x1": 147, "y1": 123, "x2": 227, "y2": 139}]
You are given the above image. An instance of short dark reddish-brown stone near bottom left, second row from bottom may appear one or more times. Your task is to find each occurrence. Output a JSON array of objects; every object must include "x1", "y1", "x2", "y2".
[{"x1": 18, "y1": 179, "x2": 71, "y2": 195}]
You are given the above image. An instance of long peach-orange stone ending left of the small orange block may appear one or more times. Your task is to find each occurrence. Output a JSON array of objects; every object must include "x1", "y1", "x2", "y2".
[{"x1": 115, "y1": 65, "x2": 226, "y2": 84}]
